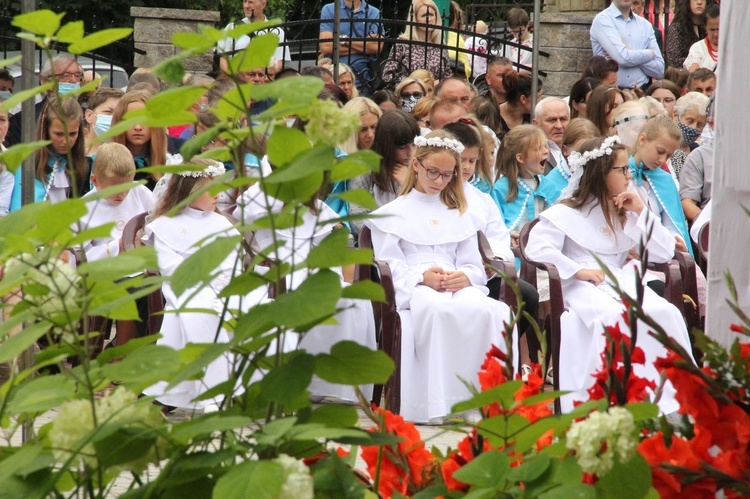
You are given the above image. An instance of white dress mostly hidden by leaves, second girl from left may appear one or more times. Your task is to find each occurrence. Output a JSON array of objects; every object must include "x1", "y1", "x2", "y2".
[{"x1": 235, "y1": 184, "x2": 377, "y2": 401}]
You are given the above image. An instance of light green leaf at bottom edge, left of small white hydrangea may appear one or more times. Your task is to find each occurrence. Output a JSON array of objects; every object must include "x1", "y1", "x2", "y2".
[{"x1": 212, "y1": 461, "x2": 285, "y2": 499}]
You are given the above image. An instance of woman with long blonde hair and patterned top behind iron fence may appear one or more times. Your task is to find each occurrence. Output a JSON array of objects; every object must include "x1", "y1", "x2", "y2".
[{"x1": 383, "y1": 0, "x2": 453, "y2": 83}]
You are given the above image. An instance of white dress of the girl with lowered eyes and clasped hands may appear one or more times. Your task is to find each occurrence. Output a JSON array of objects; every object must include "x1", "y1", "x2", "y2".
[{"x1": 367, "y1": 189, "x2": 518, "y2": 422}]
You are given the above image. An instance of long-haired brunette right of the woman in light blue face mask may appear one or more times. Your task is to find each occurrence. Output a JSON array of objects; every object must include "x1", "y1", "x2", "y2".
[{"x1": 112, "y1": 90, "x2": 167, "y2": 191}]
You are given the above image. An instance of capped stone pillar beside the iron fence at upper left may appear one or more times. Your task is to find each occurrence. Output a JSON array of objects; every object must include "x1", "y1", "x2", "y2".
[{"x1": 130, "y1": 7, "x2": 220, "y2": 73}]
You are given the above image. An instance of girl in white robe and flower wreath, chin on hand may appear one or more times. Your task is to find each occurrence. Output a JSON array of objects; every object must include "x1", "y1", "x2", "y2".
[{"x1": 526, "y1": 137, "x2": 691, "y2": 414}]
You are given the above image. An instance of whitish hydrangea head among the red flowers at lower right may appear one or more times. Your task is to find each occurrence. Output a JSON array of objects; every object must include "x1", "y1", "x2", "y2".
[{"x1": 566, "y1": 407, "x2": 636, "y2": 476}]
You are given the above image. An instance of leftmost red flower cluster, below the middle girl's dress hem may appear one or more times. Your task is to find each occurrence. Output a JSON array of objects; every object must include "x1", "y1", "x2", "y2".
[{"x1": 362, "y1": 409, "x2": 435, "y2": 497}]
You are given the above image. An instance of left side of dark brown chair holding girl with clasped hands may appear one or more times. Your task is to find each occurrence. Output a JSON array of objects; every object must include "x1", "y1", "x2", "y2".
[{"x1": 354, "y1": 226, "x2": 401, "y2": 414}]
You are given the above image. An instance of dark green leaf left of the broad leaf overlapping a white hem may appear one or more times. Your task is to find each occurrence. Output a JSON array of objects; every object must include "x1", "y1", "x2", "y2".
[{"x1": 260, "y1": 351, "x2": 315, "y2": 405}]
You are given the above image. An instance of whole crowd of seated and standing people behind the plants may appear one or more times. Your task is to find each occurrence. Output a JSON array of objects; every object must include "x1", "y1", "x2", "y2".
[{"x1": 0, "y1": 0, "x2": 719, "y2": 423}]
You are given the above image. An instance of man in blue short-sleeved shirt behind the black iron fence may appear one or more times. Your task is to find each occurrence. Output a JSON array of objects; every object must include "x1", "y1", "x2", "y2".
[{"x1": 320, "y1": 0, "x2": 381, "y2": 92}]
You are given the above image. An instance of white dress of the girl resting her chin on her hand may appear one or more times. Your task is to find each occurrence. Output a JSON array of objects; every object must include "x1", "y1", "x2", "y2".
[{"x1": 526, "y1": 203, "x2": 691, "y2": 414}]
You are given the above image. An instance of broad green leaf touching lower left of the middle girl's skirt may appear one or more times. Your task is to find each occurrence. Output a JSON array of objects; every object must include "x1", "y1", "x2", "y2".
[{"x1": 315, "y1": 341, "x2": 394, "y2": 385}]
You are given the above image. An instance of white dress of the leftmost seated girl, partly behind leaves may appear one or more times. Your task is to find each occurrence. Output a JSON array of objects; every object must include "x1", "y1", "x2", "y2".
[{"x1": 143, "y1": 207, "x2": 262, "y2": 409}]
